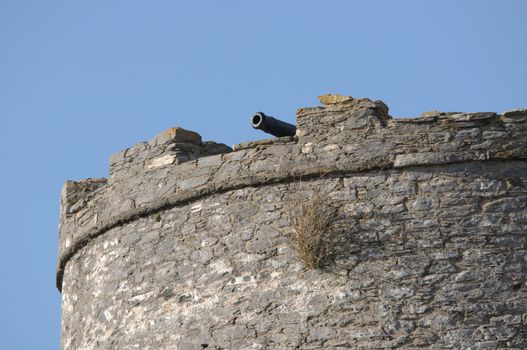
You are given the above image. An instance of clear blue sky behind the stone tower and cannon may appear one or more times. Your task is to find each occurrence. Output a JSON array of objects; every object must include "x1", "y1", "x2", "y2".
[{"x1": 0, "y1": 0, "x2": 527, "y2": 350}]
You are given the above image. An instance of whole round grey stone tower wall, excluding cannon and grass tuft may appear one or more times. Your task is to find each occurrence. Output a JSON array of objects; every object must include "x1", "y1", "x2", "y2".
[{"x1": 57, "y1": 96, "x2": 527, "y2": 350}]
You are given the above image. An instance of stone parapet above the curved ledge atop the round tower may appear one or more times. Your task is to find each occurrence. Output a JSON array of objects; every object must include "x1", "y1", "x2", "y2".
[{"x1": 57, "y1": 95, "x2": 527, "y2": 290}]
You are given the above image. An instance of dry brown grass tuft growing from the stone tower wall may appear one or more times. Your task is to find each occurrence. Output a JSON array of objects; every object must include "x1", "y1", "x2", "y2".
[{"x1": 288, "y1": 192, "x2": 335, "y2": 269}]
